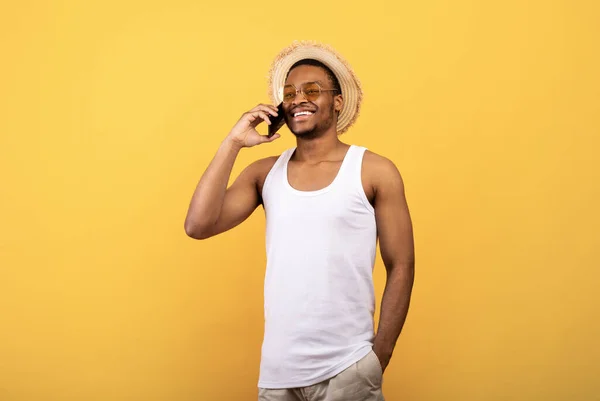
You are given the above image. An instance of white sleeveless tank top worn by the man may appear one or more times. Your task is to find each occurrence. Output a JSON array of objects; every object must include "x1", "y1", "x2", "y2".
[{"x1": 258, "y1": 145, "x2": 377, "y2": 388}]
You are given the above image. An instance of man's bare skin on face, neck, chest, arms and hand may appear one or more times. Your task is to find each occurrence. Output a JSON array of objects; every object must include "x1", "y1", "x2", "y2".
[{"x1": 185, "y1": 65, "x2": 415, "y2": 371}]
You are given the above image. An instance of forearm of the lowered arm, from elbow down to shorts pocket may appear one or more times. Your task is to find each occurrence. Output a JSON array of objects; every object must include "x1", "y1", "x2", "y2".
[{"x1": 373, "y1": 264, "x2": 414, "y2": 369}]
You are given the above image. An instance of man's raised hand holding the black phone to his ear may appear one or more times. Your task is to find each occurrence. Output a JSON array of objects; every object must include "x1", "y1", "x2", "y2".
[{"x1": 228, "y1": 104, "x2": 280, "y2": 148}]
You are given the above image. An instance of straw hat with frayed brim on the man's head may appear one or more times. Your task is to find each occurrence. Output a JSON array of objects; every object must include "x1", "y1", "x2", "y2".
[{"x1": 269, "y1": 41, "x2": 363, "y2": 134}]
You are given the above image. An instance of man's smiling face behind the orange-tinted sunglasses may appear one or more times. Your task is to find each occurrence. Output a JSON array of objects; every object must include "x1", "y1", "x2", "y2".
[{"x1": 283, "y1": 65, "x2": 342, "y2": 139}]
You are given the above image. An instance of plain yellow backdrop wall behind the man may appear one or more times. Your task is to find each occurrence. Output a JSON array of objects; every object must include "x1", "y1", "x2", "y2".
[{"x1": 0, "y1": 0, "x2": 600, "y2": 401}]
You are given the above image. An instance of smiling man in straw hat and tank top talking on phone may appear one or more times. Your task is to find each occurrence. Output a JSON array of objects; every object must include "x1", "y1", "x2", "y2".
[{"x1": 185, "y1": 42, "x2": 414, "y2": 401}]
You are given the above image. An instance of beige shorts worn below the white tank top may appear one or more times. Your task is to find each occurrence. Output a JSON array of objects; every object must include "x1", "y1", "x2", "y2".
[{"x1": 258, "y1": 351, "x2": 384, "y2": 401}]
